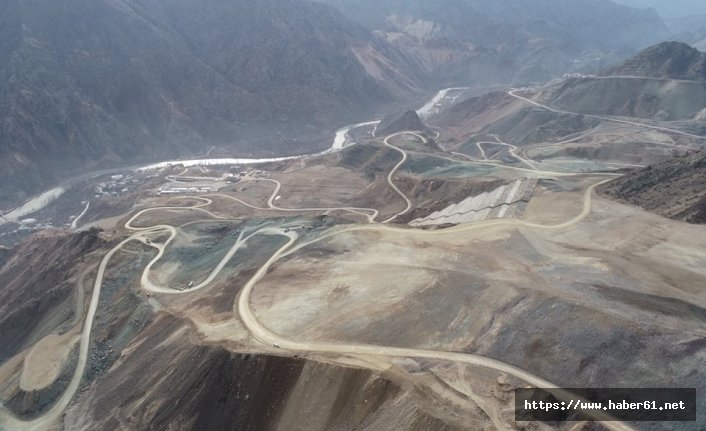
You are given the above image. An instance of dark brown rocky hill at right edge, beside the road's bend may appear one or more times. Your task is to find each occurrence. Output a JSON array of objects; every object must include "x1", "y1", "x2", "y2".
[{"x1": 601, "y1": 151, "x2": 706, "y2": 224}]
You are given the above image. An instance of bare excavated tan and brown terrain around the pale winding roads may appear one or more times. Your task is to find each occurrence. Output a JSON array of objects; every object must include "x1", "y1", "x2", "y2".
[{"x1": 0, "y1": 132, "x2": 706, "y2": 431}]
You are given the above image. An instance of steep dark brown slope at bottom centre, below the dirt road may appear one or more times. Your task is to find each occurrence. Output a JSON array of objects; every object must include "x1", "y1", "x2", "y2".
[{"x1": 64, "y1": 316, "x2": 463, "y2": 431}]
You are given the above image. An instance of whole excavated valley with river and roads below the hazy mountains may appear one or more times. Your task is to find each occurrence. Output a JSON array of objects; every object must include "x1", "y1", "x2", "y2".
[{"x1": 0, "y1": 53, "x2": 706, "y2": 430}]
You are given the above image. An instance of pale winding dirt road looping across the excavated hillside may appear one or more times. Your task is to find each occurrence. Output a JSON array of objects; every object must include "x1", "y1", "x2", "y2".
[{"x1": 0, "y1": 102, "x2": 631, "y2": 431}]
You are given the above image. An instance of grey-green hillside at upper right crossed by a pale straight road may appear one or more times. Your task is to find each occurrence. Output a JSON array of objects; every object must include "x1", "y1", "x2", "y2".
[{"x1": 427, "y1": 43, "x2": 706, "y2": 166}]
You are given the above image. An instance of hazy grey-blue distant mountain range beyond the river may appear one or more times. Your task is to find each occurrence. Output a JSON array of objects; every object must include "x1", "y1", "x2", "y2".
[{"x1": 0, "y1": 0, "x2": 680, "y2": 208}]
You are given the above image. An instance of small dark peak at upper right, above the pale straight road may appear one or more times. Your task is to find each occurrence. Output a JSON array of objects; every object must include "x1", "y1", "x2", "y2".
[{"x1": 603, "y1": 42, "x2": 706, "y2": 81}]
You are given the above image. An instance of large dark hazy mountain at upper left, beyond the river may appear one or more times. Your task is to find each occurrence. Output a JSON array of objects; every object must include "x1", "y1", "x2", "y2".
[{"x1": 0, "y1": 0, "x2": 419, "y2": 208}]
